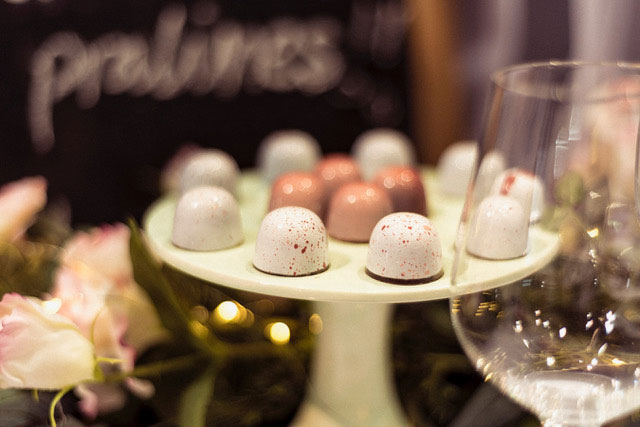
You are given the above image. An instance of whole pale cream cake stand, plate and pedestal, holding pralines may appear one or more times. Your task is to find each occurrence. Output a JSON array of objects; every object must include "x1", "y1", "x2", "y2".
[{"x1": 144, "y1": 169, "x2": 559, "y2": 427}]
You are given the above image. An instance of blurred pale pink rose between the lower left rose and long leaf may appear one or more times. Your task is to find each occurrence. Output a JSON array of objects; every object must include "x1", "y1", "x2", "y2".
[{"x1": 52, "y1": 224, "x2": 166, "y2": 417}]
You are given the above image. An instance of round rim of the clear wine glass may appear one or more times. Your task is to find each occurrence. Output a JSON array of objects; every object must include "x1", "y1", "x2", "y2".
[{"x1": 491, "y1": 60, "x2": 640, "y2": 103}]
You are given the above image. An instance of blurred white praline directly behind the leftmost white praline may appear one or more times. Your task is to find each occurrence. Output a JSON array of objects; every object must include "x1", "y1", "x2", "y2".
[{"x1": 180, "y1": 149, "x2": 240, "y2": 194}]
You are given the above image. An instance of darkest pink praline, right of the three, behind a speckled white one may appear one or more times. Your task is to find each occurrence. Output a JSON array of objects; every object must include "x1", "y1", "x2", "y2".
[{"x1": 373, "y1": 166, "x2": 427, "y2": 215}]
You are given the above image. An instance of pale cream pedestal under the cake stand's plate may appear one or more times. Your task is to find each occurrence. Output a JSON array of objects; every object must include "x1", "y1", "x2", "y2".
[{"x1": 292, "y1": 302, "x2": 408, "y2": 427}]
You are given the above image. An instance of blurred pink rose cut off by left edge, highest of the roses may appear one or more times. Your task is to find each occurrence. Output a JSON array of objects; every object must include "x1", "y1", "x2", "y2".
[{"x1": 0, "y1": 176, "x2": 47, "y2": 241}]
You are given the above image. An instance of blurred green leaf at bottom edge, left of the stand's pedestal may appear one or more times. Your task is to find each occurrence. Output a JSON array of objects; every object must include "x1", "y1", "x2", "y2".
[{"x1": 178, "y1": 365, "x2": 217, "y2": 427}]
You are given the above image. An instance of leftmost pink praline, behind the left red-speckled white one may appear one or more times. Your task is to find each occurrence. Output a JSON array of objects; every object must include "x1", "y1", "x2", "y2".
[{"x1": 269, "y1": 172, "x2": 325, "y2": 216}]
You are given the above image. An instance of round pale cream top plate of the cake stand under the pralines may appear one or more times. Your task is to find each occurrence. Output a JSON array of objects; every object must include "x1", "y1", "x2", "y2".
[{"x1": 143, "y1": 169, "x2": 558, "y2": 303}]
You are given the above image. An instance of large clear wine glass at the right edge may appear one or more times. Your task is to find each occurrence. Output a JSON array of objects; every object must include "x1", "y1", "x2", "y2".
[{"x1": 450, "y1": 62, "x2": 640, "y2": 426}]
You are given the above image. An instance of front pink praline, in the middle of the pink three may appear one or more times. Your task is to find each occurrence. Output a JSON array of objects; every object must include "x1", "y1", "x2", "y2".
[{"x1": 327, "y1": 182, "x2": 393, "y2": 243}]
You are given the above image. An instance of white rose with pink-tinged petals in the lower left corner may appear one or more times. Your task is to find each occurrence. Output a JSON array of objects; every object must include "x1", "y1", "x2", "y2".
[{"x1": 0, "y1": 294, "x2": 95, "y2": 390}]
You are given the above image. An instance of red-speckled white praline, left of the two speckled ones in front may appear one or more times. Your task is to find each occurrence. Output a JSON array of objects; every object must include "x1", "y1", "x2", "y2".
[{"x1": 253, "y1": 206, "x2": 329, "y2": 276}]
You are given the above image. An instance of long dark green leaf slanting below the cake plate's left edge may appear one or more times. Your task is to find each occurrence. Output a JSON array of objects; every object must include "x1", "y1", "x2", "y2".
[{"x1": 129, "y1": 219, "x2": 212, "y2": 353}]
